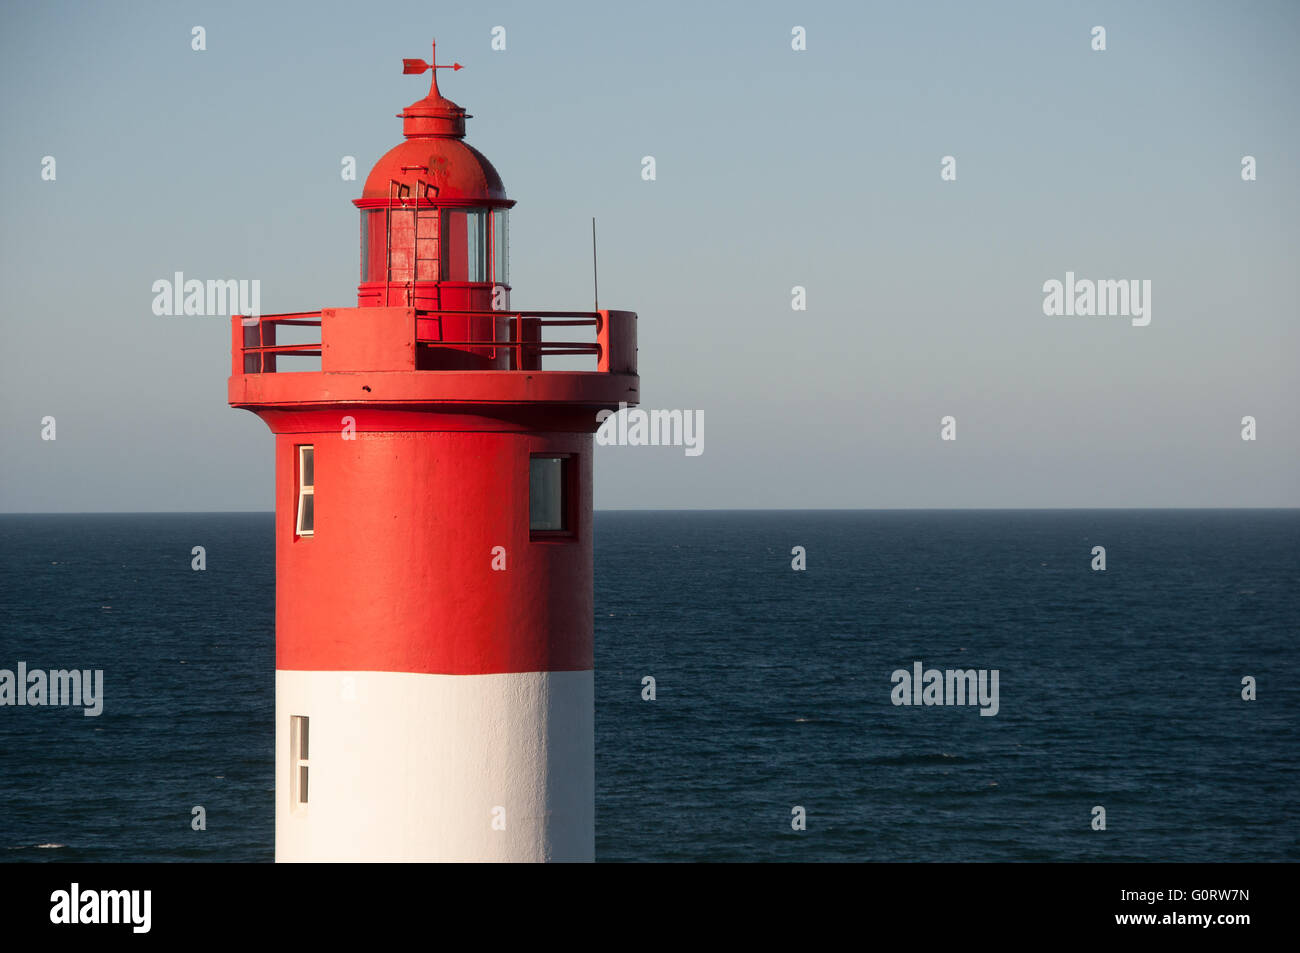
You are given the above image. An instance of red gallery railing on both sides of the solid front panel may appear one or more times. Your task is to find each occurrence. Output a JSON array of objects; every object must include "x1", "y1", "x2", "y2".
[{"x1": 240, "y1": 311, "x2": 636, "y2": 374}]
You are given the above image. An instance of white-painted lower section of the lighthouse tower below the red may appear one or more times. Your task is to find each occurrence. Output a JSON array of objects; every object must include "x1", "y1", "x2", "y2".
[{"x1": 276, "y1": 671, "x2": 595, "y2": 862}]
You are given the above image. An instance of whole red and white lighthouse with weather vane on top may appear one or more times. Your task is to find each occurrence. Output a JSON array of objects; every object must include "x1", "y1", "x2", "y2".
[{"x1": 229, "y1": 42, "x2": 638, "y2": 862}]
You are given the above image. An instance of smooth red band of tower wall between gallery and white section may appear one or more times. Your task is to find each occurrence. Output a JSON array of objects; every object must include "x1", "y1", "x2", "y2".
[{"x1": 276, "y1": 426, "x2": 593, "y2": 675}]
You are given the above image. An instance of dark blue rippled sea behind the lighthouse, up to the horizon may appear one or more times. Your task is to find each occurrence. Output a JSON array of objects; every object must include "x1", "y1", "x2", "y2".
[{"x1": 0, "y1": 510, "x2": 1300, "y2": 862}]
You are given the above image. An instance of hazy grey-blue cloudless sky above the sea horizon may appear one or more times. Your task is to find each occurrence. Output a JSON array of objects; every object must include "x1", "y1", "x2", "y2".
[{"x1": 0, "y1": 1, "x2": 1300, "y2": 512}]
